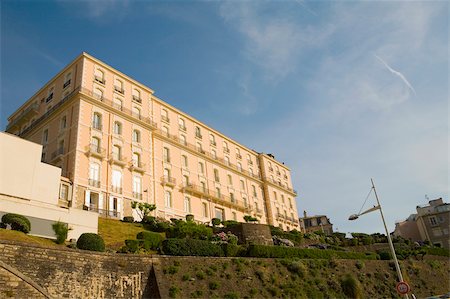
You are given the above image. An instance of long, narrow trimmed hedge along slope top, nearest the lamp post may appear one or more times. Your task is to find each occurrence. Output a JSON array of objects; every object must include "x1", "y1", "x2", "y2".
[{"x1": 247, "y1": 245, "x2": 377, "y2": 260}]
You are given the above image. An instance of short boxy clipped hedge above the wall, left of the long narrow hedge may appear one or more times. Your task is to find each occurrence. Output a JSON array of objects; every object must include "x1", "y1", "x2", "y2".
[{"x1": 162, "y1": 239, "x2": 225, "y2": 256}]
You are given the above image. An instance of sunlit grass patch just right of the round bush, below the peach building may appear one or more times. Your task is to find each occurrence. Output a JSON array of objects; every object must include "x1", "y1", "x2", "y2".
[{"x1": 98, "y1": 217, "x2": 145, "y2": 250}]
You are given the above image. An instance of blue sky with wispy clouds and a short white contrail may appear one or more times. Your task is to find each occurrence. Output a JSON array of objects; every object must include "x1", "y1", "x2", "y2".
[{"x1": 0, "y1": 0, "x2": 449, "y2": 233}]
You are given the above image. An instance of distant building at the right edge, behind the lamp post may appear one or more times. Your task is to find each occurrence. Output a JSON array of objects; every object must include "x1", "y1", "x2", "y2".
[{"x1": 394, "y1": 198, "x2": 450, "y2": 248}]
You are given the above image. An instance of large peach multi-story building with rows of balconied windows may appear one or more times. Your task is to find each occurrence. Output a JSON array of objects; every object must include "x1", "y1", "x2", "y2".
[{"x1": 6, "y1": 53, "x2": 299, "y2": 230}]
